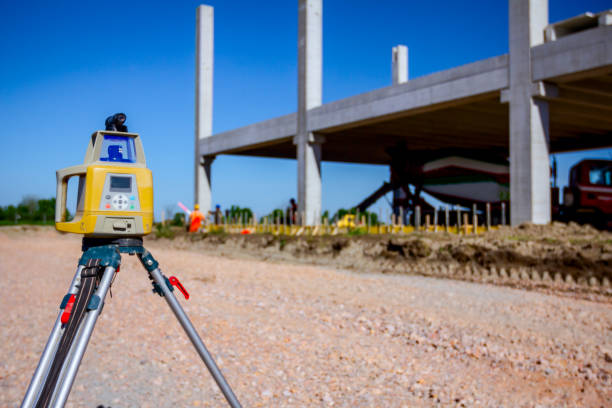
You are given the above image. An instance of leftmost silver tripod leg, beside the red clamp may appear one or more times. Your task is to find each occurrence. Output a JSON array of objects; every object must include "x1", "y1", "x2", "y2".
[{"x1": 21, "y1": 265, "x2": 83, "y2": 408}]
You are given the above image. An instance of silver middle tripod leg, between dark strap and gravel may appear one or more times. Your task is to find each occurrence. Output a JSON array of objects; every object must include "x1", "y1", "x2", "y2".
[{"x1": 50, "y1": 266, "x2": 115, "y2": 408}]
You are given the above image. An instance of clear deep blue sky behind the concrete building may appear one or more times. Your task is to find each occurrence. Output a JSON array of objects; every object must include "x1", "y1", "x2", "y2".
[{"x1": 0, "y1": 0, "x2": 612, "y2": 220}]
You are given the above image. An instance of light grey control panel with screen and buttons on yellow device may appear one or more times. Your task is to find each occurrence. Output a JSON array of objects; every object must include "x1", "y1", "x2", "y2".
[{"x1": 100, "y1": 173, "x2": 140, "y2": 211}]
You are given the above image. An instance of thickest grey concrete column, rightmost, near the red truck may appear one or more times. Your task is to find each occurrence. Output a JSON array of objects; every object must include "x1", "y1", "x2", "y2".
[{"x1": 508, "y1": 0, "x2": 551, "y2": 225}]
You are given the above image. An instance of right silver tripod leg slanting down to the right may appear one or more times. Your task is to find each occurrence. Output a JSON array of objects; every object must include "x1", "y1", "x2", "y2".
[{"x1": 140, "y1": 251, "x2": 241, "y2": 408}]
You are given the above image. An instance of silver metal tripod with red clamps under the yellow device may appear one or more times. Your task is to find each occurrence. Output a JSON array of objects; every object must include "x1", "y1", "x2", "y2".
[{"x1": 21, "y1": 238, "x2": 240, "y2": 408}]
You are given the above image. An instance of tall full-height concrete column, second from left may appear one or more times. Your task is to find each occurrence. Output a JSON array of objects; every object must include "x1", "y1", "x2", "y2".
[{"x1": 294, "y1": 0, "x2": 323, "y2": 225}]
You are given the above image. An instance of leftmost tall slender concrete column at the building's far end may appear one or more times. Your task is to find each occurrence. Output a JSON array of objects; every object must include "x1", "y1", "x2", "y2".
[{"x1": 194, "y1": 5, "x2": 214, "y2": 213}]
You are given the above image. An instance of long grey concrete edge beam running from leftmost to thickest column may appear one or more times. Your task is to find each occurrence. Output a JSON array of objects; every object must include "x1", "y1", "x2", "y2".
[{"x1": 200, "y1": 55, "x2": 508, "y2": 155}]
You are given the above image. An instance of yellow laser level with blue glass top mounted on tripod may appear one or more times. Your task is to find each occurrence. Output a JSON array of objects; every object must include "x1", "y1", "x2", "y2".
[{"x1": 55, "y1": 130, "x2": 153, "y2": 237}]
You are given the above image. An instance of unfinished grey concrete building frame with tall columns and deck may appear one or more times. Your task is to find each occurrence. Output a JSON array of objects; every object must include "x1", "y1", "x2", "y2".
[{"x1": 195, "y1": 0, "x2": 612, "y2": 225}]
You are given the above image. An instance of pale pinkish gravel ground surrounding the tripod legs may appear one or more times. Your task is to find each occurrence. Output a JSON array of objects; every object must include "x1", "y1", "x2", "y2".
[{"x1": 0, "y1": 228, "x2": 612, "y2": 408}]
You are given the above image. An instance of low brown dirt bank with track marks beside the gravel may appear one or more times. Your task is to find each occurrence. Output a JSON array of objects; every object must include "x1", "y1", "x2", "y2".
[{"x1": 147, "y1": 223, "x2": 612, "y2": 297}]
